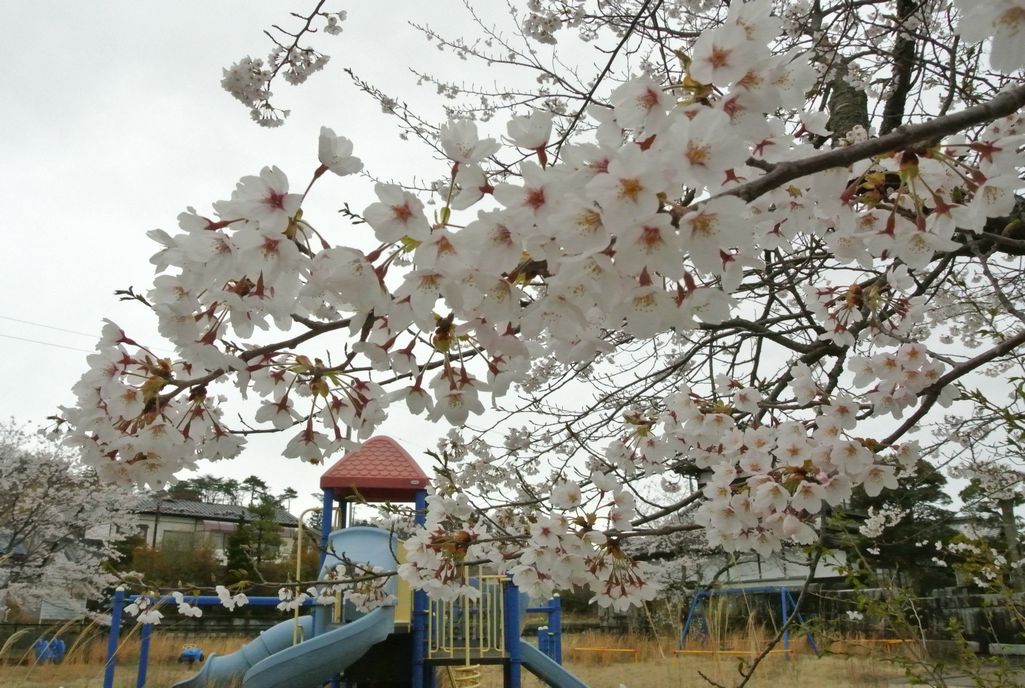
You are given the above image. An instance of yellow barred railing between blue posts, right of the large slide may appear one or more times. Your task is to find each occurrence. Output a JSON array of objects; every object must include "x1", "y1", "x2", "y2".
[{"x1": 427, "y1": 567, "x2": 505, "y2": 662}]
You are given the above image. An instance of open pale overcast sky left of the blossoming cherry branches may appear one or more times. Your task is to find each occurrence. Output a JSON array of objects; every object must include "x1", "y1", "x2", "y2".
[{"x1": 0, "y1": 0, "x2": 504, "y2": 510}]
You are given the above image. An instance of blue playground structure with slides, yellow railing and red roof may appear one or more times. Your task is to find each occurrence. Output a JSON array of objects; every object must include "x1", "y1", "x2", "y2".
[{"x1": 104, "y1": 437, "x2": 586, "y2": 688}]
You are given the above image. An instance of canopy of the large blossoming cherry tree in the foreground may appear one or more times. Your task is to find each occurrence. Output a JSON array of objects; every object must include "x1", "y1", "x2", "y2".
[{"x1": 64, "y1": 0, "x2": 1025, "y2": 607}]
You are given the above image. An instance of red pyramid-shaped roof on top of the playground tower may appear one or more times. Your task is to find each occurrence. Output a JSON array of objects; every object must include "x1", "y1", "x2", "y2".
[{"x1": 321, "y1": 436, "x2": 427, "y2": 501}]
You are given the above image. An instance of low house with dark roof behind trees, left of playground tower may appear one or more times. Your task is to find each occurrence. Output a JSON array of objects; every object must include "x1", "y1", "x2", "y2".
[{"x1": 135, "y1": 494, "x2": 299, "y2": 560}]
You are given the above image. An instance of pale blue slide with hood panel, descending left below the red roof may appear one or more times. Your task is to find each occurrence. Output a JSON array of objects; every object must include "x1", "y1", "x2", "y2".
[{"x1": 173, "y1": 527, "x2": 396, "y2": 688}]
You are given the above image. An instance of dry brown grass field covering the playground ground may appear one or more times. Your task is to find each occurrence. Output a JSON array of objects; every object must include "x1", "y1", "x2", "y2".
[{"x1": 0, "y1": 629, "x2": 926, "y2": 688}]
